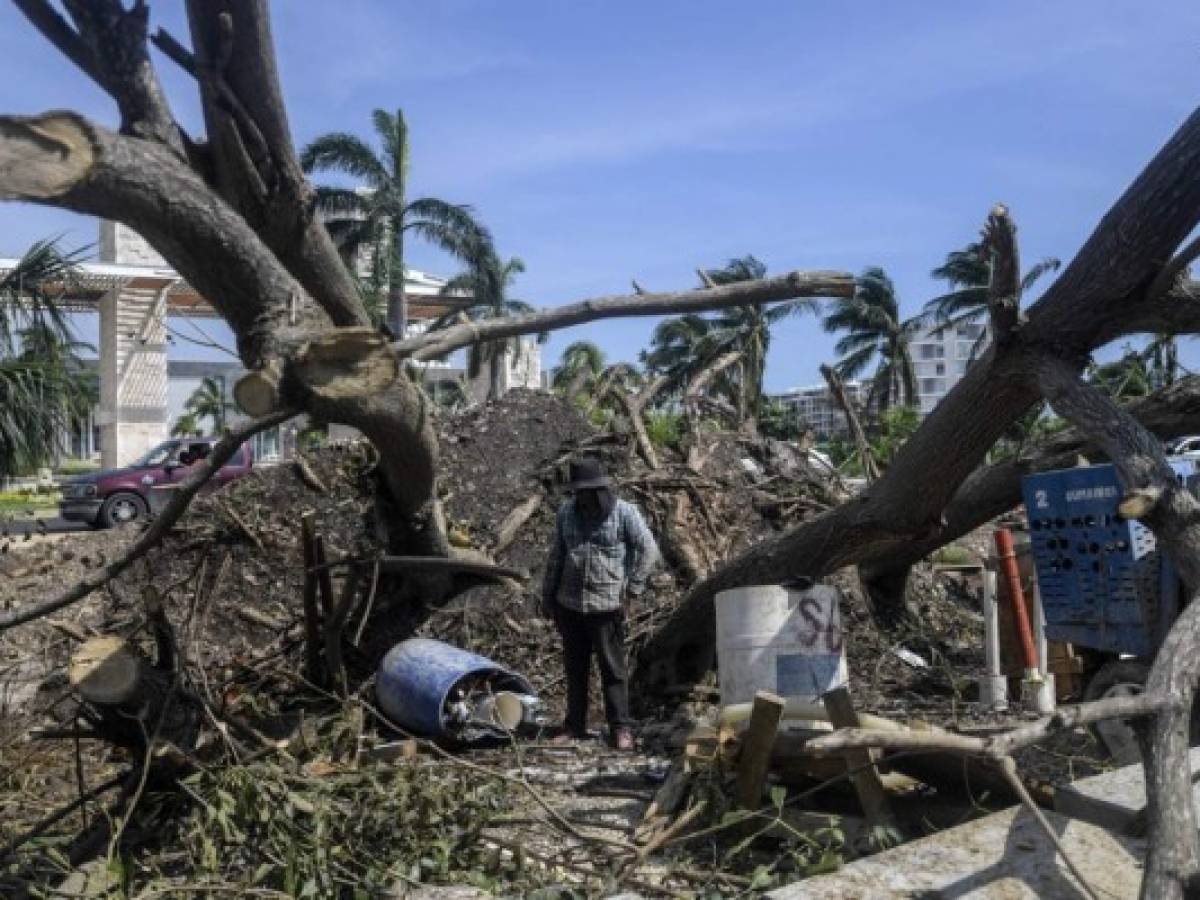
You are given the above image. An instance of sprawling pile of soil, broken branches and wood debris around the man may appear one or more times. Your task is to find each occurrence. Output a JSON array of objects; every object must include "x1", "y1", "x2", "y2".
[{"x1": 0, "y1": 391, "x2": 1051, "y2": 894}]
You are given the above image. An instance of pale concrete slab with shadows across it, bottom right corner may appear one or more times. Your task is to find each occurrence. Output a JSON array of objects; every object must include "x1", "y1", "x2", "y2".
[{"x1": 768, "y1": 808, "x2": 1146, "y2": 900}]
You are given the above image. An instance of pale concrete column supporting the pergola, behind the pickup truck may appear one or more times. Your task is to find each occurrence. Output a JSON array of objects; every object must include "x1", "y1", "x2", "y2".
[{"x1": 97, "y1": 281, "x2": 173, "y2": 468}]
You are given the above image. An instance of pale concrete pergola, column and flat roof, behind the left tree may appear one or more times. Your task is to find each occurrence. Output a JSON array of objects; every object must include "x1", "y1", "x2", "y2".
[{"x1": 0, "y1": 221, "x2": 470, "y2": 468}]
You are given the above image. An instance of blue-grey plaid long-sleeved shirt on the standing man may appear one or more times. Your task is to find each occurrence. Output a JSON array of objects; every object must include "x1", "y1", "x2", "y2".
[{"x1": 541, "y1": 500, "x2": 659, "y2": 612}]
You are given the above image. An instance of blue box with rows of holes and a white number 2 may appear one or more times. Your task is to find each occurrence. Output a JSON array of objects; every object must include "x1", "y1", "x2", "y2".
[{"x1": 1021, "y1": 458, "x2": 1196, "y2": 656}]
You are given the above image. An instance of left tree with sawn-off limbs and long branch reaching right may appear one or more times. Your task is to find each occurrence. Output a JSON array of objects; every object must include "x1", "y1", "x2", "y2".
[{"x1": 0, "y1": 0, "x2": 853, "y2": 619}]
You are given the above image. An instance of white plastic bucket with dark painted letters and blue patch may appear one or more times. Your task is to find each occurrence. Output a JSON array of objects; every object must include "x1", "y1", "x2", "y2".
[{"x1": 716, "y1": 584, "x2": 848, "y2": 706}]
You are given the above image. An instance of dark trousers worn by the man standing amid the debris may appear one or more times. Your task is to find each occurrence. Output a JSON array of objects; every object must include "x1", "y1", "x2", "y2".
[{"x1": 554, "y1": 606, "x2": 632, "y2": 734}]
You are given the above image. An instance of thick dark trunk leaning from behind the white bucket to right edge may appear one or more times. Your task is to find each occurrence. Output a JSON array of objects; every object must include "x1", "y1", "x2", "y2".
[{"x1": 638, "y1": 110, "x2": 1200, "y2": 684}]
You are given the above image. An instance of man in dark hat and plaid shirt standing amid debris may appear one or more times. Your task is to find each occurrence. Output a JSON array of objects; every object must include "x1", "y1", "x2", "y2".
[{"x1": 541, "y1": 460, "x2": 659, "y2": 750}]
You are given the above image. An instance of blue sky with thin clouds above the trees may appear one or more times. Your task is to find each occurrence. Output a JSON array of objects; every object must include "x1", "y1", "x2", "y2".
[{"x1": 0, "y1": 0, "x2": 1200, "y2": 390}]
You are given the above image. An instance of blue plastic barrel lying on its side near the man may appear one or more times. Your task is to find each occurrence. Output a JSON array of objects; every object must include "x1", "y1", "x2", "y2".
[{"x1": 376, "y1": 637, "x2": 534, "y2": 738}]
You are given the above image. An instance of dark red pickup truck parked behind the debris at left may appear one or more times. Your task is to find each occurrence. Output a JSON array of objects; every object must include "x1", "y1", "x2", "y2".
[{"x1": 59, "y1": 437, "x2": 254, "y2": 528}]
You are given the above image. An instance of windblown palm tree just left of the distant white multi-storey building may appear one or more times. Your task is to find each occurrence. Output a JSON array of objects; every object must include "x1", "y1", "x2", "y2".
[{"x1": 823, "y1": 266, "x2": 922, "y2": 410}]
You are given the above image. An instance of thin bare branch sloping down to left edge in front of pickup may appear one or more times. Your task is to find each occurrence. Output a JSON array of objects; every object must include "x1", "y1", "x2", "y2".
[{"x1": 0, "y1": 409, "x2": 295, "y2": 631}]
